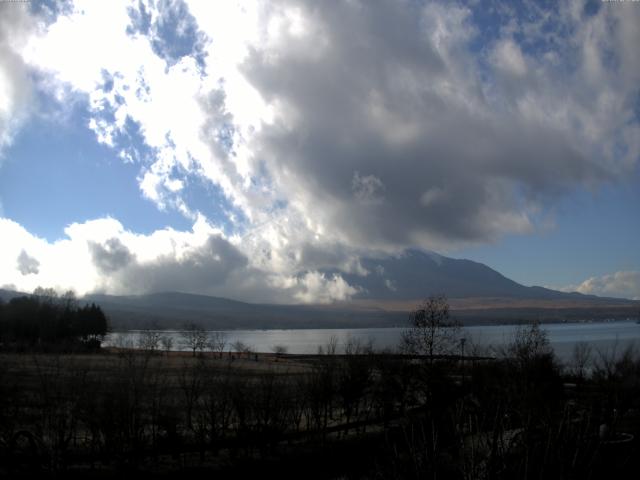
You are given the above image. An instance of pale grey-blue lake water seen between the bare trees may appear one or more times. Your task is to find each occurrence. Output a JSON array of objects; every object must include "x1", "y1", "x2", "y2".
[{"x1": 104, "y1": 320, "x2": 640, "y2": 360}]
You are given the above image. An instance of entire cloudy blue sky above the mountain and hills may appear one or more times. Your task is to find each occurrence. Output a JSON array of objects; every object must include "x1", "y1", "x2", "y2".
[{"x1": 0, "y1": 0, "x2": 640, "y2": 303}]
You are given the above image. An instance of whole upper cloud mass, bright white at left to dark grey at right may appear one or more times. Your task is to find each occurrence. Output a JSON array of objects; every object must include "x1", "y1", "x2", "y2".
[{"x1": 20, "y1": 0, "x2": 640, "y2": 250}]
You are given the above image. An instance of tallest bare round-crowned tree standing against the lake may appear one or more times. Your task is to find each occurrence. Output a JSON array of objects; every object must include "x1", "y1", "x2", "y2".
[{"x1": 402, "y1": 295, "x2": 461, "y2": 358}]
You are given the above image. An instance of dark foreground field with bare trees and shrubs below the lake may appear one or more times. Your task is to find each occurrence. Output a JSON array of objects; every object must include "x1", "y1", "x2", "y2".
[{"x1": 0, "y1": 298, "x2": 640, "y2": 479}]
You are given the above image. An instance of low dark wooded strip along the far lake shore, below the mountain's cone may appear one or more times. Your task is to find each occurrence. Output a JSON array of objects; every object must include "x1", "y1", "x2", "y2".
[{"x1": 85, "y1": 292, "x2": 640, "y2": 330}]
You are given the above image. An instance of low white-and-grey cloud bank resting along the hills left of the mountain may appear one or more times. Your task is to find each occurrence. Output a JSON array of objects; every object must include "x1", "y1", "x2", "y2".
[{"x1": 0, "y1": 217, "x2": 357, "y2": 303}]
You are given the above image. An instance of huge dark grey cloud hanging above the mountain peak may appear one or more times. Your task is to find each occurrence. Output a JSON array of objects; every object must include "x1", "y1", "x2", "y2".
[{"x1": 238, "y1": 2, "x2": 636, "y2": 248}]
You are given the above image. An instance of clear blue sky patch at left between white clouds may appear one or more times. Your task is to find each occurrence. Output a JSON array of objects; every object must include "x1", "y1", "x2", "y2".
[{"x1": 0, "y1": 92, "x2": 192, "y2": 241}]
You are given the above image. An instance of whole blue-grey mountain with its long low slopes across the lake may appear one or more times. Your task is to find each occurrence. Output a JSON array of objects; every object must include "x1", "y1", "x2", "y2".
[{"x1": 0, "y1": 250, "x2": 640, "y2": 330}]
